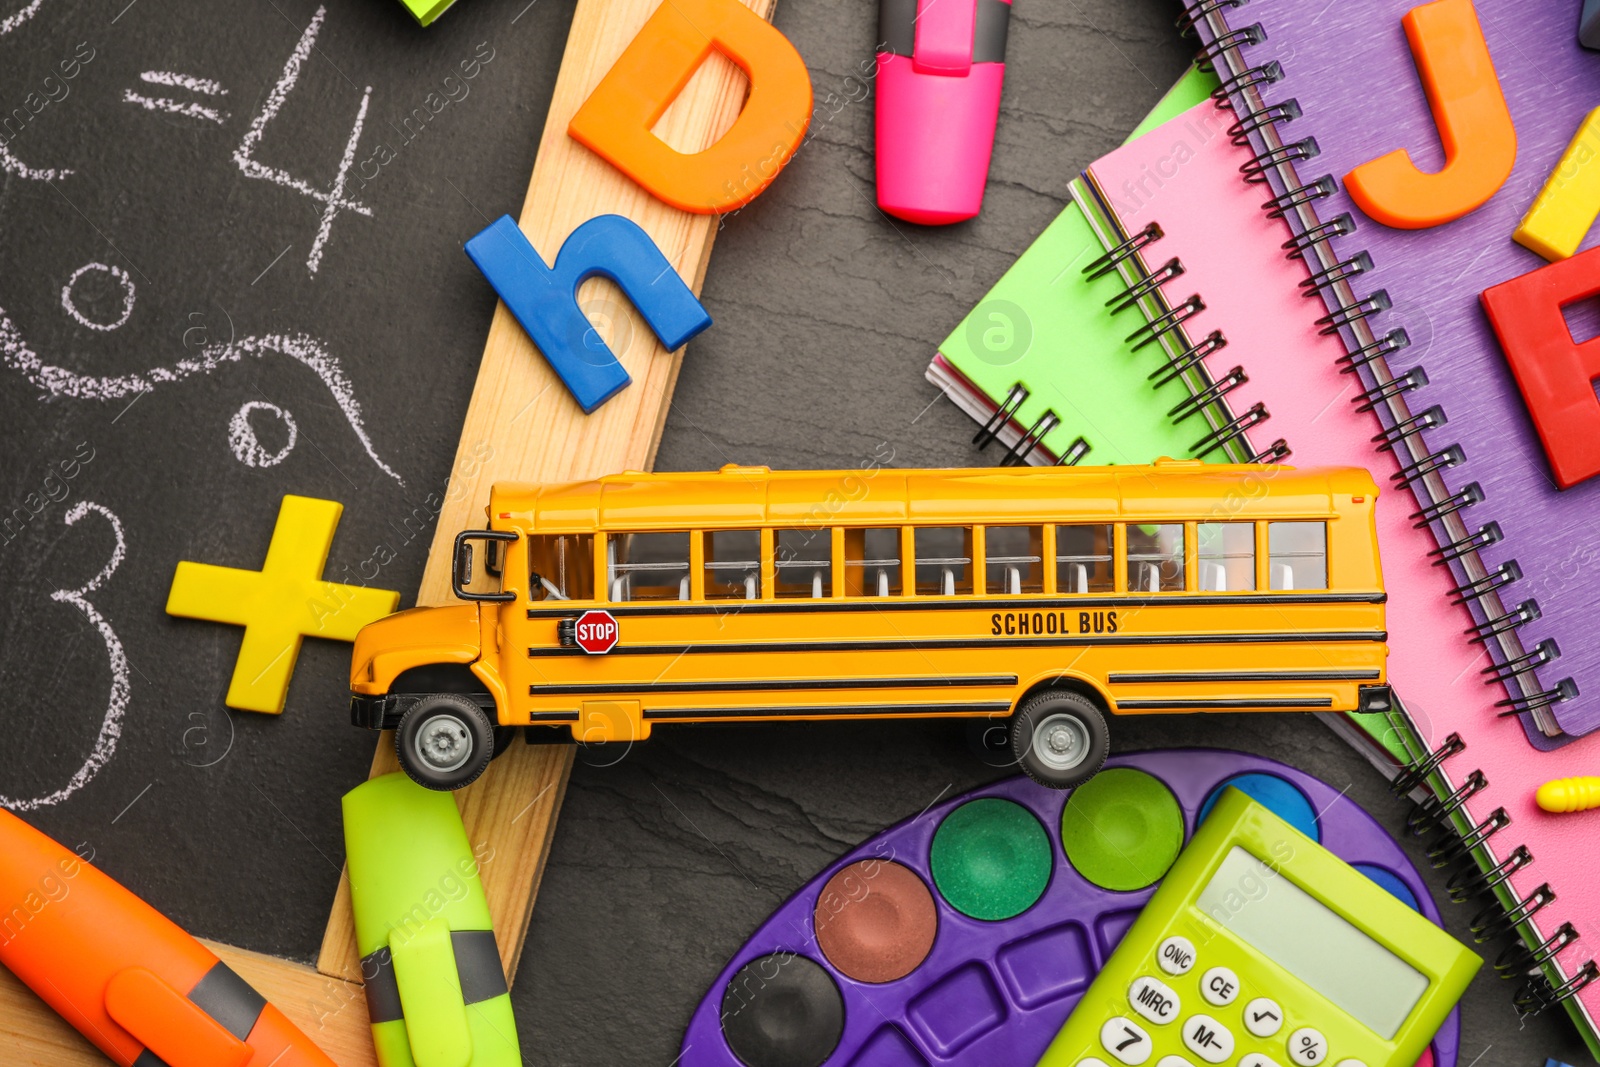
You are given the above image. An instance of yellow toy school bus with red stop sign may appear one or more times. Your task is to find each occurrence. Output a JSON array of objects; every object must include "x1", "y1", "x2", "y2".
[{"x1": 350, "y1": 459, "x2": 1389, "y2": 789}]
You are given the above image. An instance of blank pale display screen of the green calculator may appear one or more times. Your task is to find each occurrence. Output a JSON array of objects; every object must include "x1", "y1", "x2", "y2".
[{"x1": 1197, "y1": 845, "x2": 1427, "y2": 1040}]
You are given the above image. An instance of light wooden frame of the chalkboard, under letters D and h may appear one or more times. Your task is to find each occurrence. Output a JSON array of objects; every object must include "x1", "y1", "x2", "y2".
[{"x1": 0, "y1": 0, "x2": 774, "y2": 1067}]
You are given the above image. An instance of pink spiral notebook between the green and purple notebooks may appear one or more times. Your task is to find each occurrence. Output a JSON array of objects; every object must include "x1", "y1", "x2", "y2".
[{"x1": 1074, "y1": 101, "x2": 1600, "y2": 1040}]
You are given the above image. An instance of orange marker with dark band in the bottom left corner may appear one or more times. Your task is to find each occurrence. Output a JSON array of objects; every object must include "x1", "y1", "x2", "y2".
[{"x1": 0, "y1": 811, "x2": 334, "y2": 1067}]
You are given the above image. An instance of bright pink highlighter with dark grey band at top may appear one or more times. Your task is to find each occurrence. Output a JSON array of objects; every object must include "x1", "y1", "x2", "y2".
[{"x1": 877, "y1": 0, "x2": 1011, "y2": 226}]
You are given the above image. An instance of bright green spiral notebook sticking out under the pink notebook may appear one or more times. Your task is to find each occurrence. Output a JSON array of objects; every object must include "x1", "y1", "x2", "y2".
[{"x1": 926, "y1": 69, "x2": 1251, "y2": 464}]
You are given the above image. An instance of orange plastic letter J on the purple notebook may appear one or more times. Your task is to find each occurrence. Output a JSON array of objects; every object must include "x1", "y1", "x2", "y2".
[{"x1": 1344, "y1": 0, "x2": 1517, "y2": 230}]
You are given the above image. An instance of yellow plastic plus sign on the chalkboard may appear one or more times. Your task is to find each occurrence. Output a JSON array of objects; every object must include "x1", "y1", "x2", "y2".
[{"x1": 166, "y1": 496, "x2": 400, "y2": 715}]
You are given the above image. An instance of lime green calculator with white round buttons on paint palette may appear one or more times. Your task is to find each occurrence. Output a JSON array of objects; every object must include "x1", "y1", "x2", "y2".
[{"x1": 1038, "y1": 789, "x2": 1483, "y2": 1067}]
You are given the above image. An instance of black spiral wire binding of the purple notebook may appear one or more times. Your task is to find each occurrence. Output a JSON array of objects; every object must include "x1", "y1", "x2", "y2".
[{"x1": 1178, "y1": 0, "x2": 1578, "y2": 751}]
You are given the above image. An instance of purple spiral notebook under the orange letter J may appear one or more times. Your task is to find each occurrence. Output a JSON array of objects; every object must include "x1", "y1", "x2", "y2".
[{"x1": 1189, "y1": 0, "x2": 1600, "y2": 747}]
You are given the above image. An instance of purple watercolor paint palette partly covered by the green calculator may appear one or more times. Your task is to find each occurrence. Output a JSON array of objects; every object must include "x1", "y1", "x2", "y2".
[{"x1": 678, "y1": 749, "x2": 1461, "y2": 1067}]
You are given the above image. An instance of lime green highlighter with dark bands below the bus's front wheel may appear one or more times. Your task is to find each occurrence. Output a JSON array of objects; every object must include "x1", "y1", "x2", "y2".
[{"x1": 344, "y1": 773, "x2": 522, "y2": 1067}]
